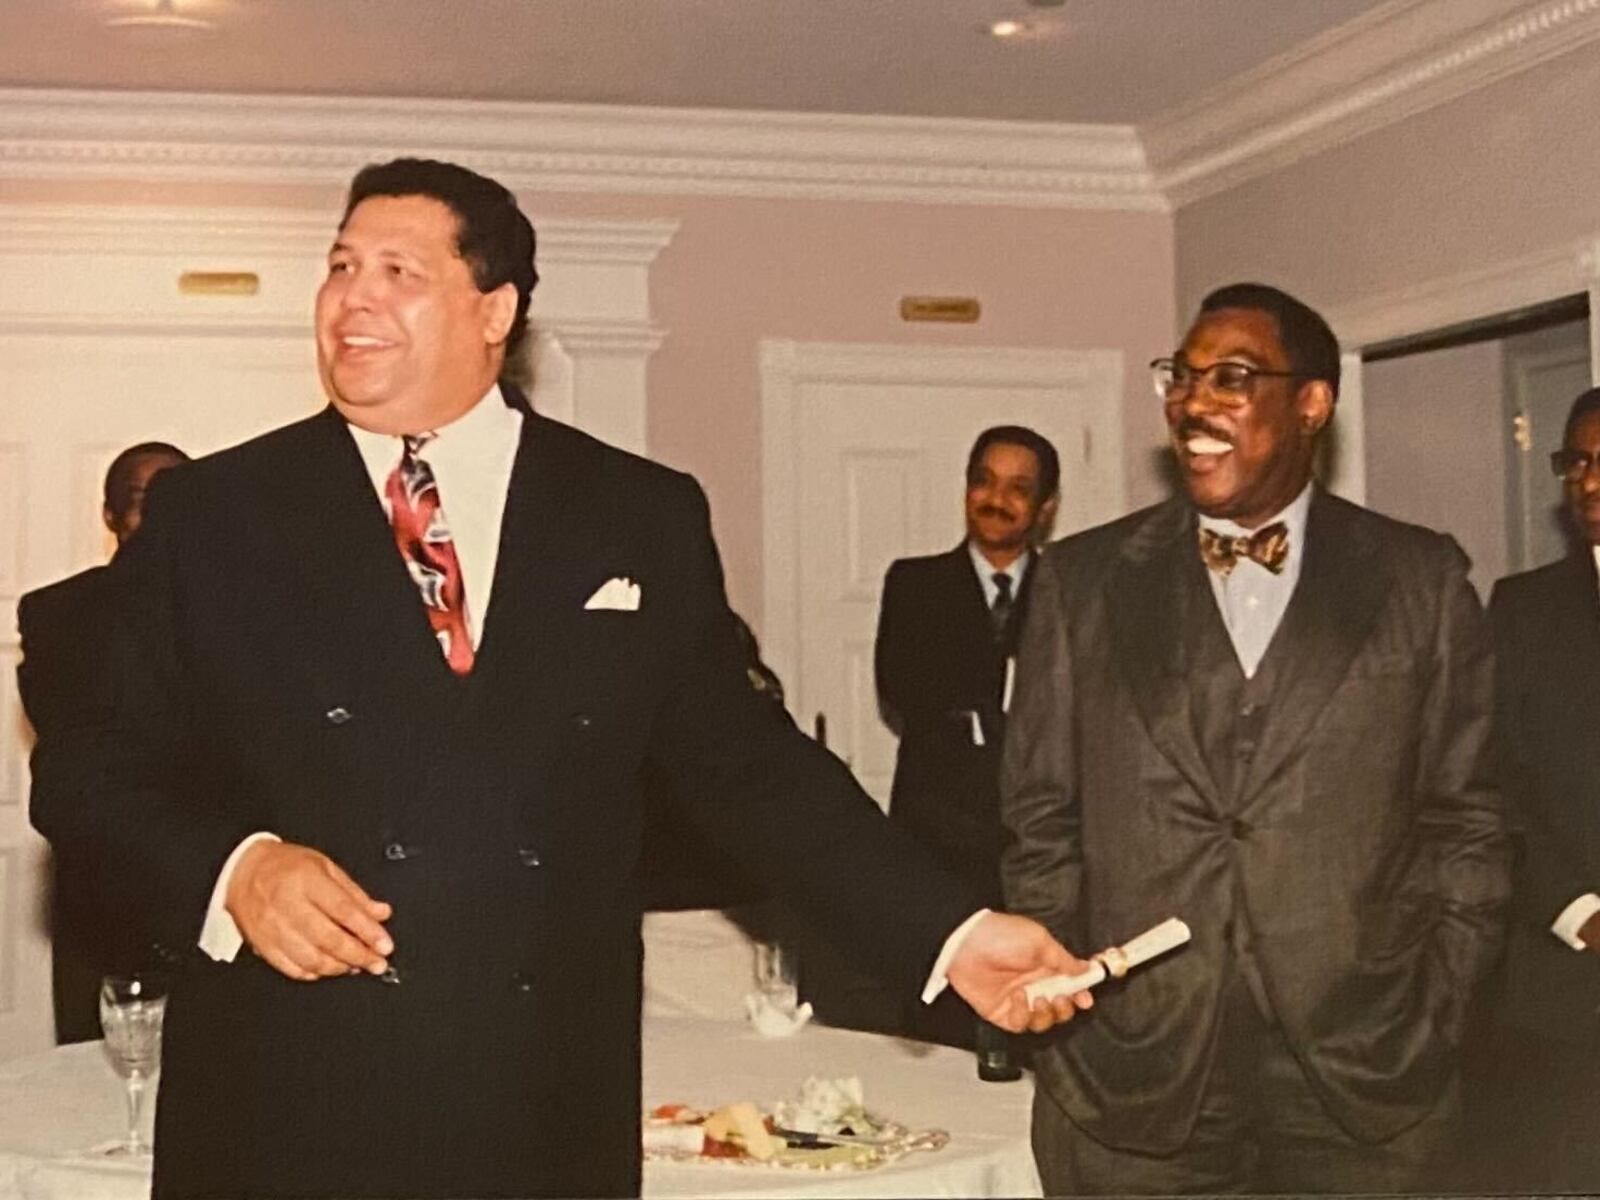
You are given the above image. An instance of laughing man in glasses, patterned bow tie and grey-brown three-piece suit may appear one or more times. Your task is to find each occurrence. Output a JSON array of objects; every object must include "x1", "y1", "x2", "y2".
[{"x1": 1002, "y1": 285, "x2": 1509, "y2": 1194}]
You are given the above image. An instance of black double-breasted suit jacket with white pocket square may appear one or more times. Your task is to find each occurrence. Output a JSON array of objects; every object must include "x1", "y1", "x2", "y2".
[{"x1": 34, "y1": 390, "x2": 970, "y2": 1197}]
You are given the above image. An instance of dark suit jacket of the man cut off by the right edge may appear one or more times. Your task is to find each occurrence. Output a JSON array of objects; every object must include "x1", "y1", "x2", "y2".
[{"x1": 1490, "y1": 547, "x2": 1600, "y2": 1042}]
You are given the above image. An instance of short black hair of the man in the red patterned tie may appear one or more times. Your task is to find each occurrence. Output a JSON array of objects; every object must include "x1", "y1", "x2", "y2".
[{"x1": 339, "y1": 158, "x2": 539, "y2": 366}]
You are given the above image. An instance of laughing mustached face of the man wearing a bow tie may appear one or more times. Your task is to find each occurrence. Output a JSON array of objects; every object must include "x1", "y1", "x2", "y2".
[{"x1": 1166, "y1": 309, "x2": 1333, "y2": 530}]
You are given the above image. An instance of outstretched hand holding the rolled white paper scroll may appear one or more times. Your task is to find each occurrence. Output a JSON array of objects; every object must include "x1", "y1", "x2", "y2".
[{"x1": 949, "y1": 912, "x2": 1094, "y2": 1034}]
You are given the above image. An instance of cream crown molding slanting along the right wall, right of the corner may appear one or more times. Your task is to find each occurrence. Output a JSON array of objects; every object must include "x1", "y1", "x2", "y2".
[{"x1": 1139, "y1": 0, "x2": 1600, "y2": 206}]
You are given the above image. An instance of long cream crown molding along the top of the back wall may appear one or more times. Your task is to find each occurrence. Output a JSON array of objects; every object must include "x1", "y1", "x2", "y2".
[{"x1": 0, "y1": 88, "x2": 1165, "y2": 211}]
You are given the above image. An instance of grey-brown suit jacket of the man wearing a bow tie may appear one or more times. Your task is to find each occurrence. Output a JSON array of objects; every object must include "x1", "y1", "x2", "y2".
[{"x1": 1002, "y1": 490, "x2": 1509, "y2": 1152}]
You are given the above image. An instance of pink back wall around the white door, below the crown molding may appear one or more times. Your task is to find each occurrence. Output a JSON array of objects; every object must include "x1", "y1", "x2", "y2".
[{"x1": 0, "y1": 181, "x2": 1174, "y2": 629}]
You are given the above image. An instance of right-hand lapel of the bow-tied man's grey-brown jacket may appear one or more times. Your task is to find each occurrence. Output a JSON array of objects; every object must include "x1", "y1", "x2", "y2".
[{"x1": 1240, "y1": 488, "x2": 1390, "y2": 806}]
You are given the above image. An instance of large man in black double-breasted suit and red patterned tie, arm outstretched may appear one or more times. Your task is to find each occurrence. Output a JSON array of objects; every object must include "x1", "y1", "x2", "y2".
[{"x1": 34, "y1": 160, "x2": 1088, "y2": 1197}]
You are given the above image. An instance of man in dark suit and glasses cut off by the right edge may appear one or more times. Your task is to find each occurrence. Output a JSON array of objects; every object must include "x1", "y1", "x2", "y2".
[{"x1": 1483, "y1": 389, "x2": 1600, "y2": 1194}]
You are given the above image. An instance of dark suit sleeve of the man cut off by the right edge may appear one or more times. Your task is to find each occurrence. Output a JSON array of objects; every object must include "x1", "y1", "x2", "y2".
[{"x1": 1490, "y1": 581, "x2": 1600, "y2": 934}]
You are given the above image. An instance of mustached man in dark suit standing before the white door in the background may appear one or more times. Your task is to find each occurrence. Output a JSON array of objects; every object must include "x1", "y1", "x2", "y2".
[{"x1": 875, "y1": 426, "x2": 1061, "y2": 1046}]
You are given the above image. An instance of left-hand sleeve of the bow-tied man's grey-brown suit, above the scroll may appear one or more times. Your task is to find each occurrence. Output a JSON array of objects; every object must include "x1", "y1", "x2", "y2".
[{"x1": 1000, "y1": 558, "x2": 1083, "y2": 949}]
